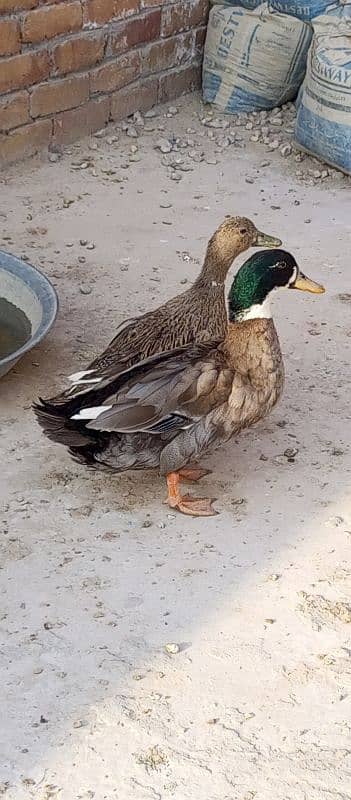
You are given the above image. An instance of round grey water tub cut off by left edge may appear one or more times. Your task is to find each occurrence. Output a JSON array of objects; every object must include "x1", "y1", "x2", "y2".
[{"x1": 0, "y1": 250, "x2": 58, "y2": 378}]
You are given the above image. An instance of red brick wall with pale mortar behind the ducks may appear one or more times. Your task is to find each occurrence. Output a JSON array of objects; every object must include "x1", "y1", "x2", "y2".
[{"x1": 0, "y1": 0, "x2": 208, "y2": 163}]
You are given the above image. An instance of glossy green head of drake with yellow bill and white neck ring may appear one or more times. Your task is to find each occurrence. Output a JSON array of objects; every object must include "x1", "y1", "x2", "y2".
[{"x1": 228, "y1": 249, "x2": 325, "y2": 322}]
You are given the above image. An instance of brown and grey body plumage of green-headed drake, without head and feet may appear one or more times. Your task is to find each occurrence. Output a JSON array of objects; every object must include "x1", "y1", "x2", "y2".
[{"x1": 37, "y1": 319, "x2": 283, "y2": 475}]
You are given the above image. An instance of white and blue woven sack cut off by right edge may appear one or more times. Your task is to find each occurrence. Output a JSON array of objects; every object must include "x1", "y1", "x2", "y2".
[{"x1": 295, "y1": 5, "x2": 351, "y2": 175}]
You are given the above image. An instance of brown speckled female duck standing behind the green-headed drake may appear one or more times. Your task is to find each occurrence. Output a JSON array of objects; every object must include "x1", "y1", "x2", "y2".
[{"x1": 65, "y1": 217, "x2": 281, "y2": 394}]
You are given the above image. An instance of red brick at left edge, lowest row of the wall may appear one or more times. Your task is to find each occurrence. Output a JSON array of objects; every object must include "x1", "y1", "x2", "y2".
[{"x1": 0, "y1": 119, "x2": 52, "y2": 164}]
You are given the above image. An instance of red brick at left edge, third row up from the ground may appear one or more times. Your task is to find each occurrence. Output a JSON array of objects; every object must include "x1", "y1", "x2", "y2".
[{"x1": 0, "y1": 50, "x2": 50, "y2": 93}]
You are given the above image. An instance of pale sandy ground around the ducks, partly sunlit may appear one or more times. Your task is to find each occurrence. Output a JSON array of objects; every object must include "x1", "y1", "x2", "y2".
[{"x1": 0, "y1": 98, "x2": 351, "y2": 800}]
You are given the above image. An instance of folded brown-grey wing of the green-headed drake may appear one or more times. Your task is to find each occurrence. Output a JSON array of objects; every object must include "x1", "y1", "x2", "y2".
[{"x1": 71, "y1": 343, "x2": 233, "y2": 434}]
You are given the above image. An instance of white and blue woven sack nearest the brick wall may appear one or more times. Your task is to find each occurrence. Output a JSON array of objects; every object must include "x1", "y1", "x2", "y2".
[{"x1": 202, "y1": 3, "x2": 312, "y2": 113}]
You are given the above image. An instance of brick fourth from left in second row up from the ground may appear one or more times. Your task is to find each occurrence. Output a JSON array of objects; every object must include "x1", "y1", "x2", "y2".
[{"x1": 143, "y1": 31, "x2": 193, "y2": 74}]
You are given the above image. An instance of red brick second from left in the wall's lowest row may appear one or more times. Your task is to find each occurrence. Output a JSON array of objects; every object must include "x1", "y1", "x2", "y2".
[{"x1": 54, "y1": 97, "x2": 110, "y2": 144}]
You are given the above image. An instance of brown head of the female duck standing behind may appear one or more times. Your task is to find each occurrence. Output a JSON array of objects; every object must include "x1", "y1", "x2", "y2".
[{"x1": 204, "y1": 216, "x2": 281, "y2": 278}]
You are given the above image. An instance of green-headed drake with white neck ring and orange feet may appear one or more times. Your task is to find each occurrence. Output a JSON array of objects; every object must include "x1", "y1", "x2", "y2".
[{"x1": 35, "y1": 249, "x2": 325, "y2": 517}]
